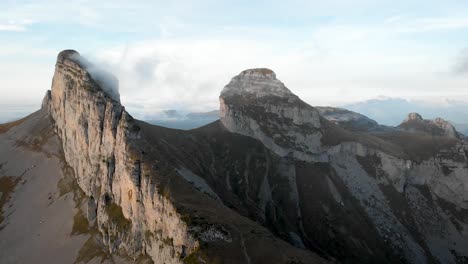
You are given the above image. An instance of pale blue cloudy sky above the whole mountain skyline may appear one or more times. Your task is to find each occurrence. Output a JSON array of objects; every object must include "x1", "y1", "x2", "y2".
[{"x1": 0, "y1": 0, "x2": 468, "y2": 118}]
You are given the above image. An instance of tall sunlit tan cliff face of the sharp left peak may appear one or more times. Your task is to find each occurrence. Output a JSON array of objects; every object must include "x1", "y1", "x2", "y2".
[{"x1": 43, "y1": 51, "x2": 198, "y2": 263}]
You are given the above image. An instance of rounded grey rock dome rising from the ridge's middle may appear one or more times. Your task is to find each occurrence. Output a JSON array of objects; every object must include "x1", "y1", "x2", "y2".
[{"x1": 219, "y1": 69, "x2": 322, "y2": 160}]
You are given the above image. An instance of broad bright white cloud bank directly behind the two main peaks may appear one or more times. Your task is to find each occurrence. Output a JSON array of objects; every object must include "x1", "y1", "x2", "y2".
[{"x1": 79, "y1": 34, "x2": 468, "y2": 118}]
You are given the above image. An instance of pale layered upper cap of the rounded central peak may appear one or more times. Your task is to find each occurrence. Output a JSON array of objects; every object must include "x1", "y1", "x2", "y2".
[{"x1": 221, "y1": 68, "x2": 297, "y2": 97}]
